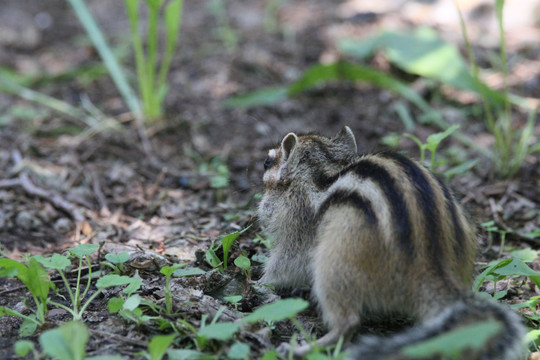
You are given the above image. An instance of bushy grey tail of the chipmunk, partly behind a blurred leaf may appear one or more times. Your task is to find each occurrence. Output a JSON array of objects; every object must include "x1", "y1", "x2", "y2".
[{"x1": 347, "y1": 296, "x2": 525, "y2": 360}]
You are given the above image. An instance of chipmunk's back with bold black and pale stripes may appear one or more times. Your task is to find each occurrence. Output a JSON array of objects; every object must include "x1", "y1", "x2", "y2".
[{"x1": 316, "y1": 150, "x2": 476, "y2": 287}]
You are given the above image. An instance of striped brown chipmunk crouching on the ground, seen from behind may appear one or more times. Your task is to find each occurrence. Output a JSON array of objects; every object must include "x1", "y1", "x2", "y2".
[{"x1": 258, "y1": 127, "x2": 524, "y2": 360}]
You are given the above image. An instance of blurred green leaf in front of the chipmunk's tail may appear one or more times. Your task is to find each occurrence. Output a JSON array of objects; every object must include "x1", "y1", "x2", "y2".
[{"x1": 401, "y1": 320, "x2": 503, "y2": 359}]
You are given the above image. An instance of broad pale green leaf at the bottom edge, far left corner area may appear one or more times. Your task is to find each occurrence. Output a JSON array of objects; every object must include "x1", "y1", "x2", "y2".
[{"x1": 39, "y1": 321, "x2": 88, "y2": 360}]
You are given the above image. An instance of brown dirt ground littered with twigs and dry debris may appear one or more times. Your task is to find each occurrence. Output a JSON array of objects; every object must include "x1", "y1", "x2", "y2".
[{"x1": 0, "y1": 0, "x2": 540, "y2": 359}]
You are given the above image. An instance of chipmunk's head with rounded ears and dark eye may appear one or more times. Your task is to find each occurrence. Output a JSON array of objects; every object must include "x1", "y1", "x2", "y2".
[{"x1": 263, "y1": 126, "x2": 358, "y2": 189}]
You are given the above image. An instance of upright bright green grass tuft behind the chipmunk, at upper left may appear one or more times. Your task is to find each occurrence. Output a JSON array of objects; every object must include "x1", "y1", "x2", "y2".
[{"x1": 125, "y1": 0, "x2": 184, "y2": 119}]
